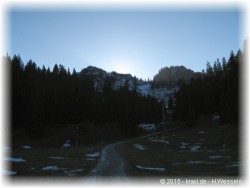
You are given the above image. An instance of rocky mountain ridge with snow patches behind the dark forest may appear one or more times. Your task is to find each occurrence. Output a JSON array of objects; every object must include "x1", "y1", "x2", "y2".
[{"x1": 79, "y1": 66, "x2": 195, "y2": 104}]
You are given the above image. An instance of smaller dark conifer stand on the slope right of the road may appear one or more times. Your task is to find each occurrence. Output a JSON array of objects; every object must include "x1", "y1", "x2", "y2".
[{"x1": 173, "y1": 44, "x2": 246, "y2": 126}]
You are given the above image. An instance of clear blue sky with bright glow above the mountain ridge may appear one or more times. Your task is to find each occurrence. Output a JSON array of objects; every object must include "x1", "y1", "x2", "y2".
[{"x1": 8, "y1": 8, "x2": 243, "y2": 79}]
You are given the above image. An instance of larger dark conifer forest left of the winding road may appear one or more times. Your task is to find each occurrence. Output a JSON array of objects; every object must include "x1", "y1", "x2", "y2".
[{"x1": 5, "y1": 55, "x2": 161, "y2": 138}]
